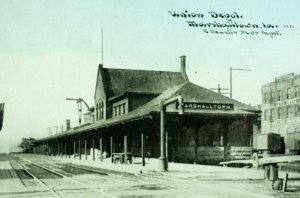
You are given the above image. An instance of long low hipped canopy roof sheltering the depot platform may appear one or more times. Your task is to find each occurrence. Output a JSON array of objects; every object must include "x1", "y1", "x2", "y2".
[{"x1": 38, "y1": 82, "x2": 260, "y2": 141}]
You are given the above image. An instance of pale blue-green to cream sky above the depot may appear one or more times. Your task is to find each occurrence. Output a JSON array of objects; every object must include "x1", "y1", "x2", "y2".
[{"x1": 0, "y1": 0, "x2": 300, "y2": 152}]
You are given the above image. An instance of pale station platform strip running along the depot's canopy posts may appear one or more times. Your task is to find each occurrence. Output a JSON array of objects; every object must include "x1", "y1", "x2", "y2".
[{"x1": 20, "y1": 154, "x2": 270, "y2": 181}]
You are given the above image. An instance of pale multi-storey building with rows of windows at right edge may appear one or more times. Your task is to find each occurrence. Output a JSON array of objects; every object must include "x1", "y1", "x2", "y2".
[{"x1": 261, "y1": 73, "x2": 300, "y2": 153}]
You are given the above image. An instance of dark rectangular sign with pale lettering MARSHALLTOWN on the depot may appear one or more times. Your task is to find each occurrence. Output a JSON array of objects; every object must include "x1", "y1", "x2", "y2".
[{"x1": 183, "y1": 102, "x2": 234, "y2": 111}]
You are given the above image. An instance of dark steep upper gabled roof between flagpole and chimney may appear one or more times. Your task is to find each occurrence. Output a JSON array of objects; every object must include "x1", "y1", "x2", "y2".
[{"x1": 99, "y1": 68, "x2": 185, "y2": 98}]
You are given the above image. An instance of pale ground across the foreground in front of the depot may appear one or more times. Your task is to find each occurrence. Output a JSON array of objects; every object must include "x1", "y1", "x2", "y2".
[{"x1": 0, "y1": 154, "x2": 300, "y2": 198}]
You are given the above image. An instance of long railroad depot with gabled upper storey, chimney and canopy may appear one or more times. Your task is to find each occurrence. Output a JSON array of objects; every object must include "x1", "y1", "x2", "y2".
[{"x1": 35, "y1": 56, "x2": 259, "y2": 164}]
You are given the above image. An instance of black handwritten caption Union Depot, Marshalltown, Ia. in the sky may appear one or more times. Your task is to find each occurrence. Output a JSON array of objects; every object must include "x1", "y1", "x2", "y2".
[{"x1": 168, "y1": 10, "x2": 294, "y2": 38}]
